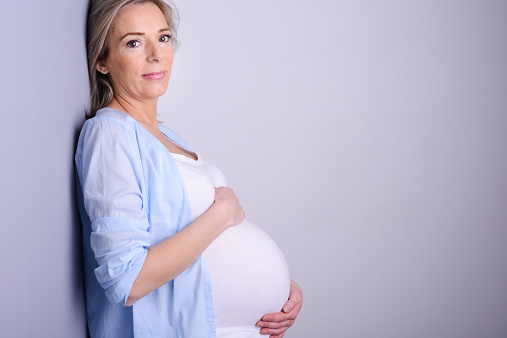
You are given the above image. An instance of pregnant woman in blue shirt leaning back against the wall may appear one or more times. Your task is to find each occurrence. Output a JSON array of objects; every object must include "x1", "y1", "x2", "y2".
[{"x1": 76, "y1": 0, "x2": 302, "y2": 338}]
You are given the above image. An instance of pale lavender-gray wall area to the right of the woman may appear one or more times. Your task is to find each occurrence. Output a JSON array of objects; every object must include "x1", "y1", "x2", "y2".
[{"x1": 159, "y1": 0, "x2": 507, "y2": 338}]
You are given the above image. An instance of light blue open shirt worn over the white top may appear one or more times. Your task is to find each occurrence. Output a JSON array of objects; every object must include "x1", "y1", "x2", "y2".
[{"x1": 75, "y1": 108, "x2": 215, "y2": 338}]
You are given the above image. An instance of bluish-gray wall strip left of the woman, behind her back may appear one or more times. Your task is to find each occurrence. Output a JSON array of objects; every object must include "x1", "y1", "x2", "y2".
[{"x1": 0, "y1": 0, "x2": 89, "y2": 338}]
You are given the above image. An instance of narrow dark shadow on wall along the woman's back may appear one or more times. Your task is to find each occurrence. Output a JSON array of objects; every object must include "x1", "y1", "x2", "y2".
[{"x1": 70, "y1": 123, "x2": 90, "y2": 338}]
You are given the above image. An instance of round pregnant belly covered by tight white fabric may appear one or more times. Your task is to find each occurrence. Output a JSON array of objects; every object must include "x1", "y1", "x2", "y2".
[{"x1": 203, "y1": 220, "x2": 290, "y2": 328}]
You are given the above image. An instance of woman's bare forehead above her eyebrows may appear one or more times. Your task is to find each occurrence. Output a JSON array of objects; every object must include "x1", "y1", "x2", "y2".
[{"x1": 112, "y1": 2, "x2": 168, "y2": 35}]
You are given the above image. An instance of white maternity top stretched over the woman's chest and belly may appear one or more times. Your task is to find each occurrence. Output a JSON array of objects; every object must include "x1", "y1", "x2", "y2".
[{"x1": 173, "y1": 154, "x2": 290, "y2": 338}]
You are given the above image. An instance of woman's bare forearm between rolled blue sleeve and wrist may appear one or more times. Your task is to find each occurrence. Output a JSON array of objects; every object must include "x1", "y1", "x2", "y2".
[{"x1": 126, "y1": 207, "x2": 227, "y2": 306}]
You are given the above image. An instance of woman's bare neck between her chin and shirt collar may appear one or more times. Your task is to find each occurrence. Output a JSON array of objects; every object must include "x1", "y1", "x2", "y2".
[{"x1": 107, "y1": 94, "x2": 158, "y2": 128}]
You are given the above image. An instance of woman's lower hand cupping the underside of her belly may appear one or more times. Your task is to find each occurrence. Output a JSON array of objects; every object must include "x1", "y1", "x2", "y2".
[{"x1": 255, "y1": 280, "x2": 303, "y2": 338}]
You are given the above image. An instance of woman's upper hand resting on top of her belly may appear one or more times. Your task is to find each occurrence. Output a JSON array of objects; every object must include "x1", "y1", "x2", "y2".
[{"x1": 212, "y1": 187, "x2": 245, "y2": 228}]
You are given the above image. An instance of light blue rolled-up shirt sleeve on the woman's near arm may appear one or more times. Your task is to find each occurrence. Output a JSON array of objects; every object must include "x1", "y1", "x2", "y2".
[{"x1": 76, "y1": 119, "x2": 151, "y2": 305}]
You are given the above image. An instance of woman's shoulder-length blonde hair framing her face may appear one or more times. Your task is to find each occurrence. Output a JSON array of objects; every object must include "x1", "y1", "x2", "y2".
[{"x1": 86, "y1": 0, "x2": 179, "y2": 119}]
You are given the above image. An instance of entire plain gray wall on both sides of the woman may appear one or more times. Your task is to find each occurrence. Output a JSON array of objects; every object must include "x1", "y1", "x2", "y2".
[{"x1": 0, "y1": 0, "x2": 507, "y2": 338}]
